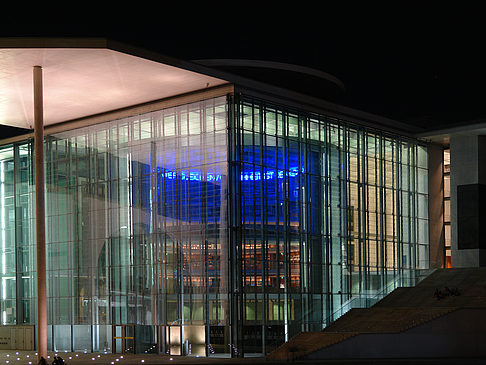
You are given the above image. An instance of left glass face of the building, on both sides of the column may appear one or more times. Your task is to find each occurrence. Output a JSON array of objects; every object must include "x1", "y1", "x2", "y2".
[{"x1": 0, "y1": 97, "x2": 229, "y2": 355}]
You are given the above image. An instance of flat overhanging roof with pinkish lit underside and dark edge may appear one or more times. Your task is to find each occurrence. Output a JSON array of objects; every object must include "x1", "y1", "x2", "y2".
[{"x1": 0, "y1": 38, "x2": 423, "y2": 138}]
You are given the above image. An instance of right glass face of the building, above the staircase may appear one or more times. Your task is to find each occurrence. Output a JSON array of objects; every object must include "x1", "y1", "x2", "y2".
[{"x1": 230, "y1": 95, "x2": 428, "y2": 353}]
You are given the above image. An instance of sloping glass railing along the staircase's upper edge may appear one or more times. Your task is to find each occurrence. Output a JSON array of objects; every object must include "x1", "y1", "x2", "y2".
[{"x1": 323, "y1": 269, "x2": 434, "y2": 329}]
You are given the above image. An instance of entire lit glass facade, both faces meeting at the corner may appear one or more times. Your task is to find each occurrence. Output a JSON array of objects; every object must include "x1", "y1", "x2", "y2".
[{"x1": 0, "y1": 92, "x2": 429, "y2": 355}]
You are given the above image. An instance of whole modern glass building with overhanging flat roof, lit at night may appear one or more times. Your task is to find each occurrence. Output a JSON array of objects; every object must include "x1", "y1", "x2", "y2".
[{"x1": 0, "y1": 39, "x2": 466, "y2": 356}]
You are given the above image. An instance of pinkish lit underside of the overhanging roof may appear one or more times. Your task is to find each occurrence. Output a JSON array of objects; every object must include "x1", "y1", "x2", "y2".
[{"x1": 0, "y1": 48, "x2": 227, "y2": 129}]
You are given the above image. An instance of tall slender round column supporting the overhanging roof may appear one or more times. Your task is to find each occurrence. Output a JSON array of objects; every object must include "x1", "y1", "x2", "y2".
[{"x1": 34, "y1": 66, "x2": 47, "y2": 359}]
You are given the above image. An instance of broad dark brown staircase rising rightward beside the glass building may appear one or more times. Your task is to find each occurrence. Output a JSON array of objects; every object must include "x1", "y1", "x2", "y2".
[{"x1": 267, "y1": 268, "x2": 486, "y2": 361}]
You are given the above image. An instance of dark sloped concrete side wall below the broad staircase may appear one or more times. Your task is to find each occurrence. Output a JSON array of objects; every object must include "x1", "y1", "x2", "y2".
[{"x1": 305, "y1": 308, "x2": 486, "y2": 360}]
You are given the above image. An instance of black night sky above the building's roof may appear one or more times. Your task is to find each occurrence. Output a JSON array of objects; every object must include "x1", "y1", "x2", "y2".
[{"x1": 0, "y1": 2, "x2": 486, "y2": 134}]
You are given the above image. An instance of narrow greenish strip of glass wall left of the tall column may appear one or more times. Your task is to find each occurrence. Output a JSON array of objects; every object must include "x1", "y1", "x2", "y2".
[{"x1": 0, "y1": 142, "x2": 36, "y2": 325}]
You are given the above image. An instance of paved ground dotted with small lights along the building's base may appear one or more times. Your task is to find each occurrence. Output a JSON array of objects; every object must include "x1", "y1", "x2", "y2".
[{"x1": 0, "y1": 350, "x2": 486, "y2": 365}]
